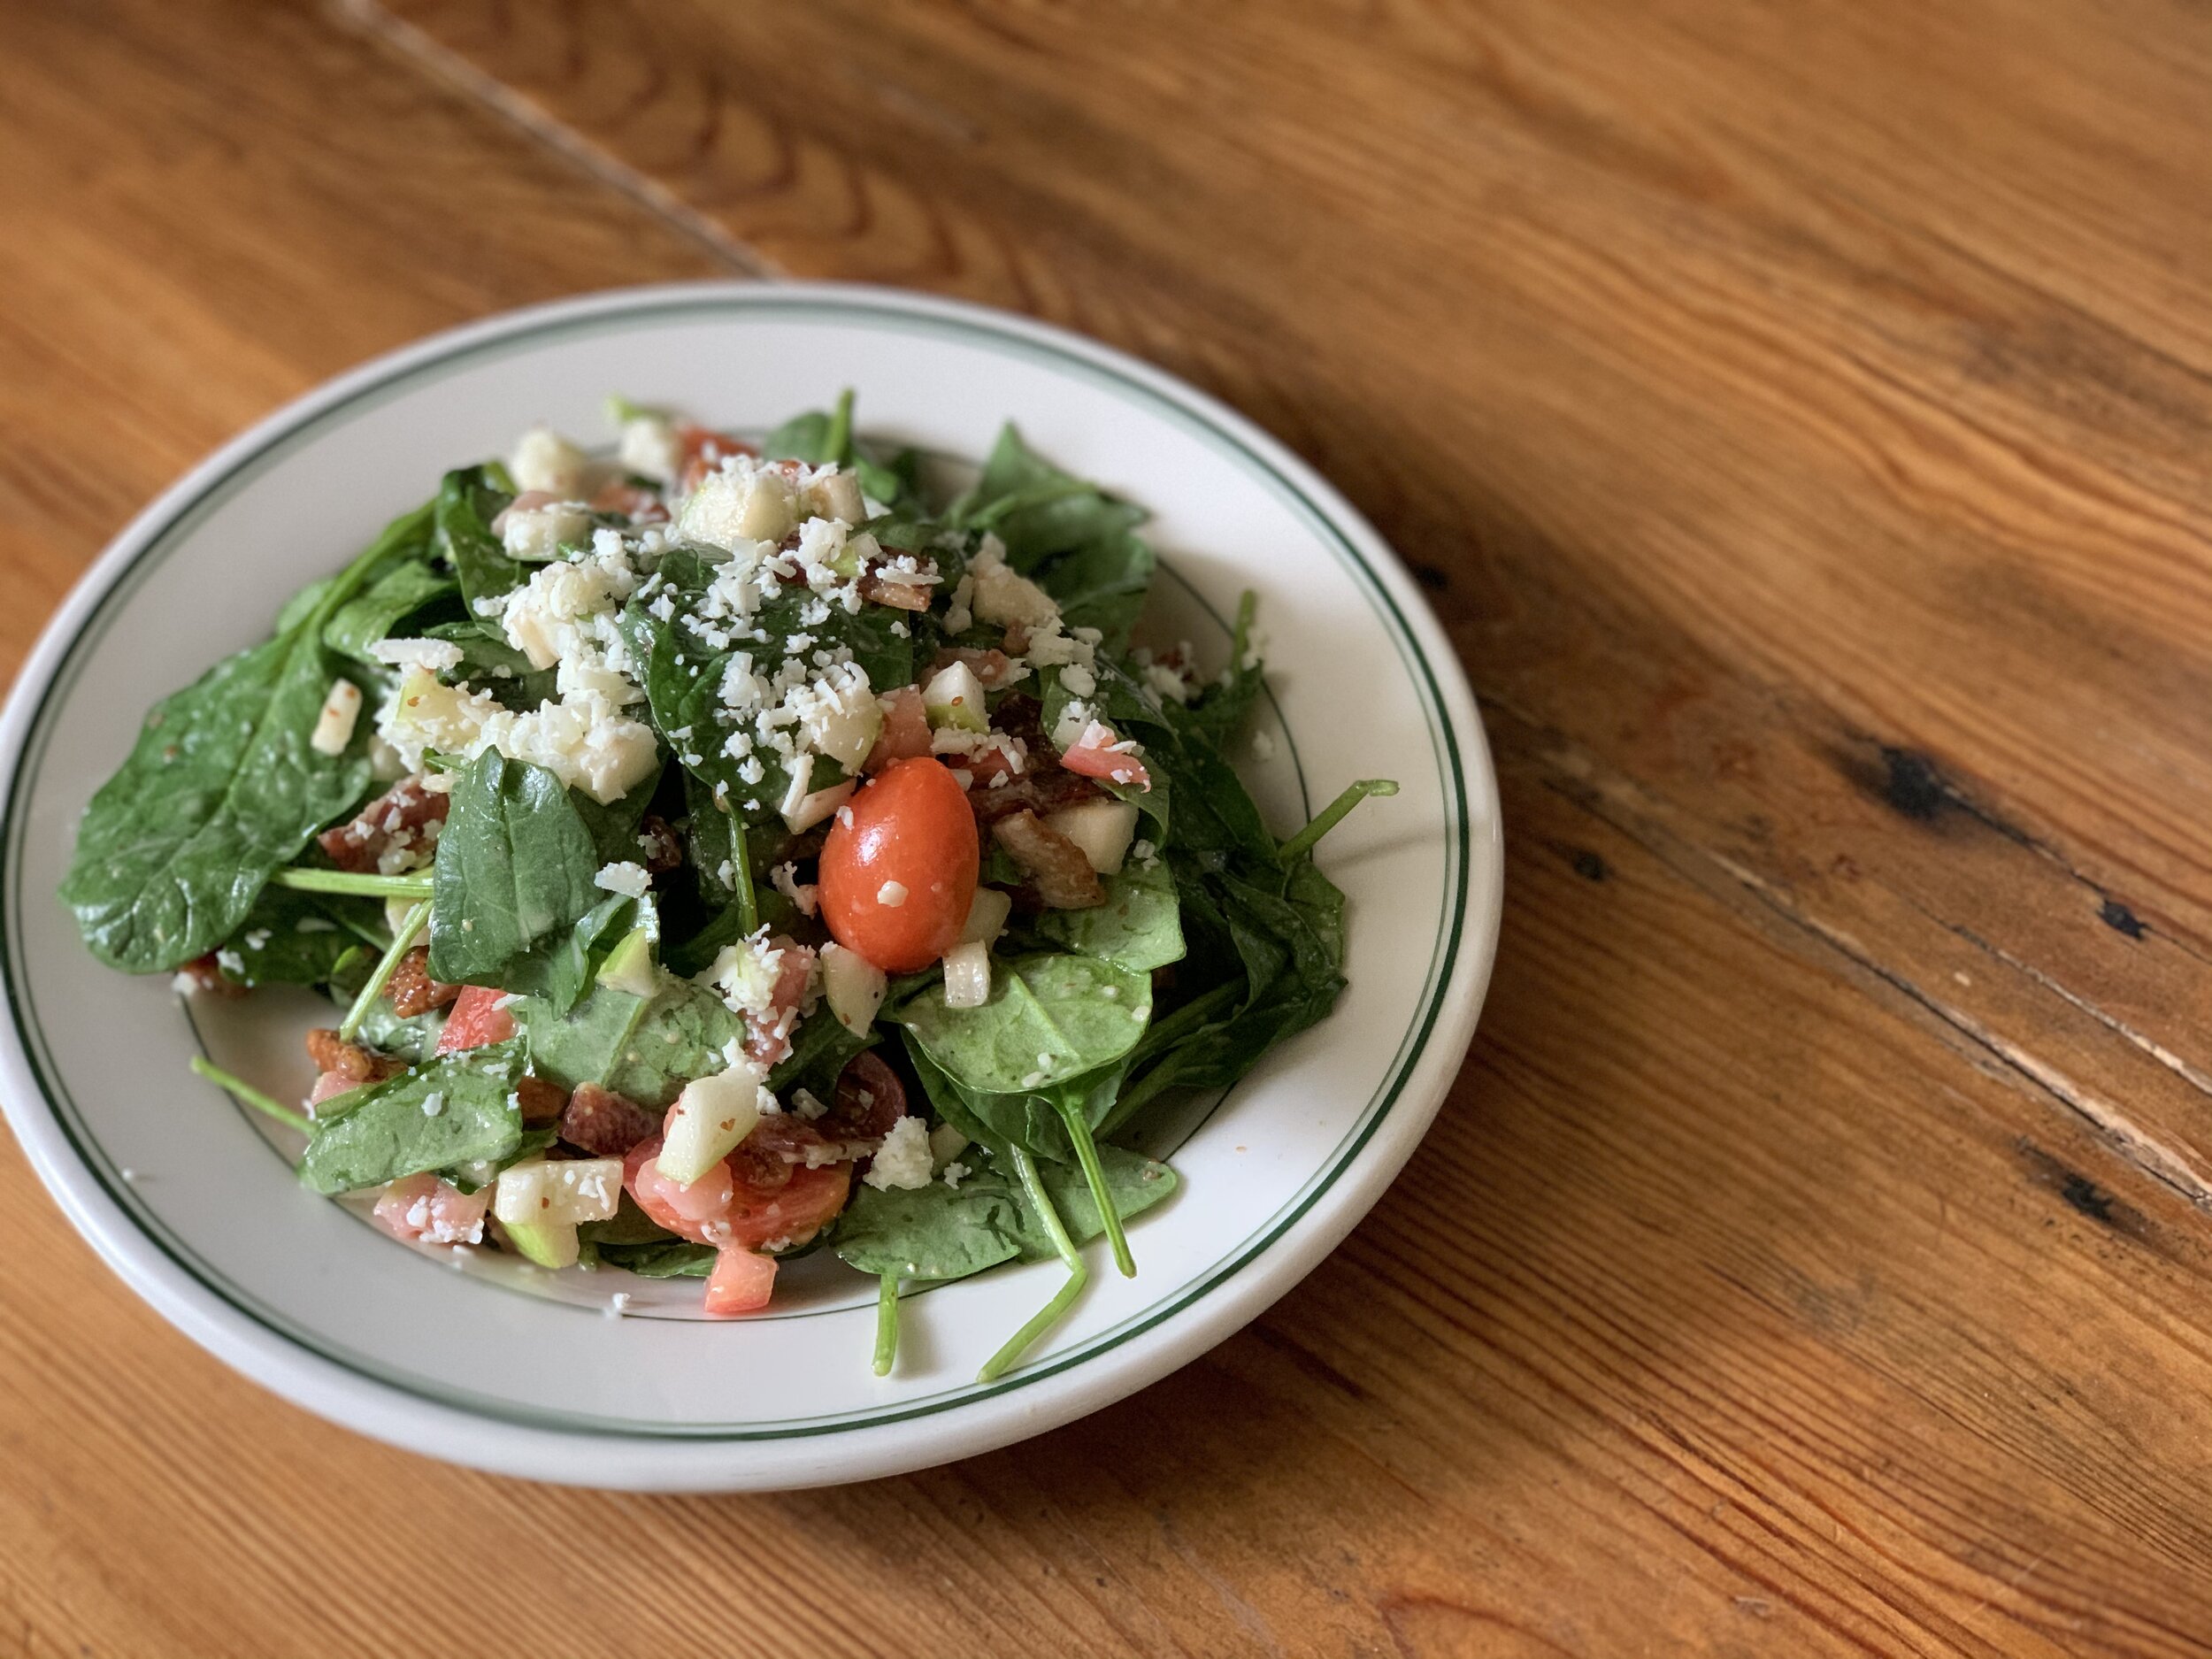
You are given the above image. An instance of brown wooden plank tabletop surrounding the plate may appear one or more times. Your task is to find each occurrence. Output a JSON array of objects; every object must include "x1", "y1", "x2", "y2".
[{"x1": 0, "y1": 0, "x2": 2212, "y2": 1659}]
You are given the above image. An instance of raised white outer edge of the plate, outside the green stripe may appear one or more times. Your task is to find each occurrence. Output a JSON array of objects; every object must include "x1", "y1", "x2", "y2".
[{"x1": 0, "y1": 281, "x2": 1502, "y2": 1491}]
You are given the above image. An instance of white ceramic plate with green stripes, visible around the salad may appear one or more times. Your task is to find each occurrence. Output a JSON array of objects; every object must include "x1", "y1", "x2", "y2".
[{"x1": 0, "y1": 283, "x2": 1502, "y2": 1491}]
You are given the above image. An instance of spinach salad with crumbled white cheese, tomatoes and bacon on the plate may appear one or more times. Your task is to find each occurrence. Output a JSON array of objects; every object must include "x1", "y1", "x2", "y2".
[{"x1": 62, "y1": 394, "x2": 1394, "y2": 1379}]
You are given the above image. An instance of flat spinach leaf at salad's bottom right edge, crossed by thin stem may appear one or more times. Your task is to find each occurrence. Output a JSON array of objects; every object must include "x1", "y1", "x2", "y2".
[{"x1": 830, "y1": 1146, "x2": 1177, "y2": 1279}]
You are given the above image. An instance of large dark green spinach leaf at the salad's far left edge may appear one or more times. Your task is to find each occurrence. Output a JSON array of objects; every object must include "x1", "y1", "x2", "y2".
[{"x1": 62, "y1": 500, "x2": 425, "y2": 973}]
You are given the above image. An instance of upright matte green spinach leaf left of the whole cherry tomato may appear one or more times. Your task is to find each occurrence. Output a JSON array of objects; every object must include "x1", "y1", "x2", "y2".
[{"x1": 429, "y1": 750, "x2": 606, "y2": 991}]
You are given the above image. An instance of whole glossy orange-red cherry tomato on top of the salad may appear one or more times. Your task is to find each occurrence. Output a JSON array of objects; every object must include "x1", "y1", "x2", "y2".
[{"x1": 821, "y1": 759, "x2": 982, "y2": 973}]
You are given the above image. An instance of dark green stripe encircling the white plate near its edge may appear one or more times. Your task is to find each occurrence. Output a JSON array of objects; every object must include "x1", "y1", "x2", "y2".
[{"x1": 0, "y1": 290, "x2": 1473, "y2": 1442}]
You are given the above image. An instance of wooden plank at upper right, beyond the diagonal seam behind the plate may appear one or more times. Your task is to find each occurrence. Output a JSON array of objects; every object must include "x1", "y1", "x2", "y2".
[{"x1": 380, "y1": 0, "x2": 2212, "y2": 1202}]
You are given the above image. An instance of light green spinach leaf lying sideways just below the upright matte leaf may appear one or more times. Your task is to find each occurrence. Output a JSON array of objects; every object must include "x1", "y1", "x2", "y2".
[{"x1": 509, "y1": 980, "x2": 746, "y2": 1110}]
